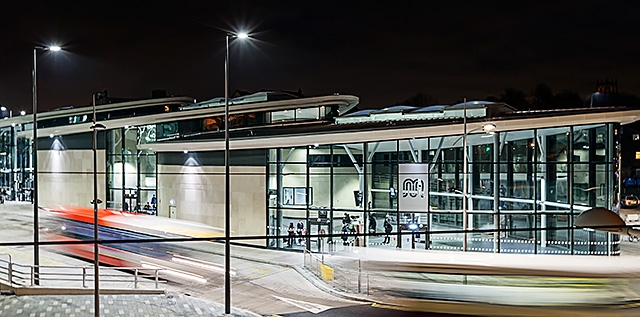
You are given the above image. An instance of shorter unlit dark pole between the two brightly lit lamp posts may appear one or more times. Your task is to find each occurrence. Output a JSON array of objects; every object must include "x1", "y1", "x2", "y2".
[{"x1": 91, "y1": 93, "x2": 107, "y2": 317}]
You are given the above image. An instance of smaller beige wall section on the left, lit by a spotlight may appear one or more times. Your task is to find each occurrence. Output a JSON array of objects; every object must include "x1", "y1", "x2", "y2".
[{"x1": 38, "y1": 150, "x2": 106, "y2": 207}]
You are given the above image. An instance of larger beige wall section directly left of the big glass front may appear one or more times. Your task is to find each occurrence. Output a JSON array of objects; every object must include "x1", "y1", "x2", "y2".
[{"x1": 157, "y1": 165, "x2": 267, "y2": 246}]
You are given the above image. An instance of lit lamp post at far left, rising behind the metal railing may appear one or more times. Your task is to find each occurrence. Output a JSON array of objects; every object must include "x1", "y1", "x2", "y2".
[{"x1": 31, "y1": 45, "x2": 61, "y2": 285}]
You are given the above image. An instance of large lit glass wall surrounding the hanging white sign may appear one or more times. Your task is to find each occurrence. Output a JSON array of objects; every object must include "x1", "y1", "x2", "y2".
[{"x1": 268, "y1": 124, "x2": 617, "y2": 254}]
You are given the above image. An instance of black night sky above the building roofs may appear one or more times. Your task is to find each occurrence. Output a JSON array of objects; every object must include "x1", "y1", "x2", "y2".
[{"x1": 0, "y1": 0, "x2": 640, "y2": 112}]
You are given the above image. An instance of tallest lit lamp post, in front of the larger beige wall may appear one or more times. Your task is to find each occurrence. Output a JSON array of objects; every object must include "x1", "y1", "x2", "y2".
[{"x1": 224, "y1": 32, "x2": 249, "y2": 314}]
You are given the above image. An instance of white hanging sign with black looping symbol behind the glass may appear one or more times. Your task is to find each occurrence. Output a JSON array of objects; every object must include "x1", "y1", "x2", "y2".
[{"x1": 398, "y1": 164, "x2": 429, "y2": 212}]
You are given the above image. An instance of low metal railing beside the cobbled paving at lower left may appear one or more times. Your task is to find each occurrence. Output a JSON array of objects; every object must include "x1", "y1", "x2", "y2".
[{"x1": 0, "y1": 253, "x2": 165, "y2": 291}]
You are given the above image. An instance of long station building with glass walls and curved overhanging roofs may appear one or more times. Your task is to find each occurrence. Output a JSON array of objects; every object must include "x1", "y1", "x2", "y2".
[{"x1": 0, "y1": 92, "x2": 640, "y2": 255}]
